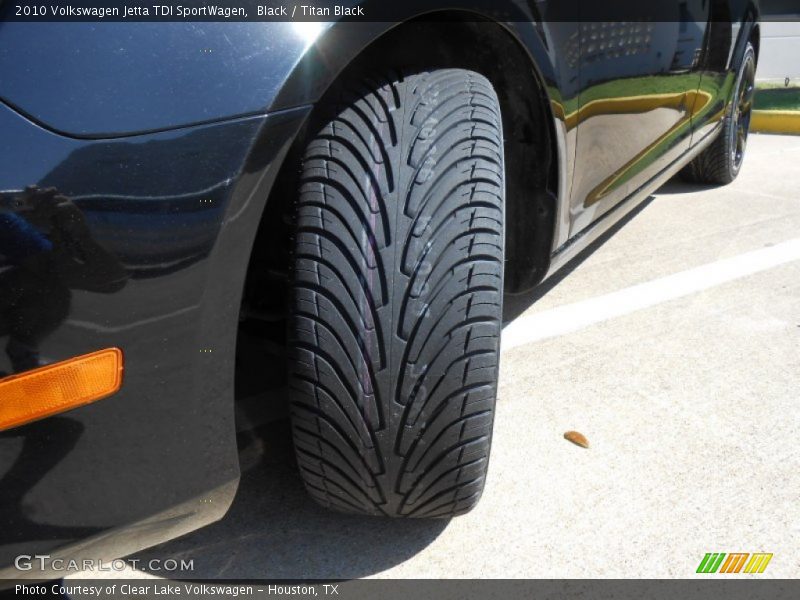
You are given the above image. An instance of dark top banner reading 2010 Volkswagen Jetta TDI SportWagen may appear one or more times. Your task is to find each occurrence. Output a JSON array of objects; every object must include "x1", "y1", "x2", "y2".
[{"x1": 0, "y1": 0, "x2": 800, "y2": 22}]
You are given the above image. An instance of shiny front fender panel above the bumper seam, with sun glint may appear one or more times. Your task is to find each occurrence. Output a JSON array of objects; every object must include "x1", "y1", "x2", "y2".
[{"x1": 0, "y1": 23, "x2": 316, "y2": 137}]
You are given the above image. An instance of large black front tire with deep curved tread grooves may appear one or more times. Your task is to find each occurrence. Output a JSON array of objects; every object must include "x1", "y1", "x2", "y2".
[{"x1": 288, "y1": 64, "x2": 505, "y2": 517}]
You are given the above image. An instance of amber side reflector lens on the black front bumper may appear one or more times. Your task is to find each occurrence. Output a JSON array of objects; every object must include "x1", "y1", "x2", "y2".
[{"x1": 0, "y1": 348, "x2": 122, "y2": 431}]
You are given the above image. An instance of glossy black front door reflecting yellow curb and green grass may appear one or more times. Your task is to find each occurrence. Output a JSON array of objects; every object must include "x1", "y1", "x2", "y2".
[{"x1": 570, "y1": 0, "x2": 708, "y2": 235}]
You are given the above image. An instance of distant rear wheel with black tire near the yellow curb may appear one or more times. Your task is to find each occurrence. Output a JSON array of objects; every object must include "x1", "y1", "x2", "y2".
[{"x1": 681, "y1": 42, "x2": 756, "y2": 185}]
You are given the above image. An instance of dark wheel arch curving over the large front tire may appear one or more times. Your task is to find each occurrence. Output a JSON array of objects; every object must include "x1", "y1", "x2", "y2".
[{"x1": 266, "y1": 11, "x2": 565, "y2": 293}]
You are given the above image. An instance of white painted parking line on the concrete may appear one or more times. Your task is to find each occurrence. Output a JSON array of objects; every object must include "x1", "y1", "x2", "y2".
[{"x1": 500, "y1": 238, "x2": 800, "y2": 351}]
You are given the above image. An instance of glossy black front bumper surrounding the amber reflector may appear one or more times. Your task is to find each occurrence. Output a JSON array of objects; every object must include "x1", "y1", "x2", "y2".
[{"x1": 0, "y1": 107, "x2": 307, "y2": 565}]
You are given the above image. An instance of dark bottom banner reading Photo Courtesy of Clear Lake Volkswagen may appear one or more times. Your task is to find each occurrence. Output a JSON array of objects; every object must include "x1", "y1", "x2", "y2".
[{"x1": 0, "y1": 578, "x2": 800, "y2": 600}]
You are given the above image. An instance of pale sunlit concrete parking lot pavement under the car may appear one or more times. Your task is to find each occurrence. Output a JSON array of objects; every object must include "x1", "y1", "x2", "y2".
[{"x1": 72, "y1": 136, "x2": 800, "y2": 579}]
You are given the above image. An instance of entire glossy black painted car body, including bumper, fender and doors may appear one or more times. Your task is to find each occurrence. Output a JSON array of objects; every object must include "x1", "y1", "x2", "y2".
[{"x1": 0, "y1": 0, "x2": 757, "y2": 575}]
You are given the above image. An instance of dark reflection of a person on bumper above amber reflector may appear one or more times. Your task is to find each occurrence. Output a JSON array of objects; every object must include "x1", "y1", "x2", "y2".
[{"x1": 0, "y1": 186, "x2": 127, "y2": 375}]
